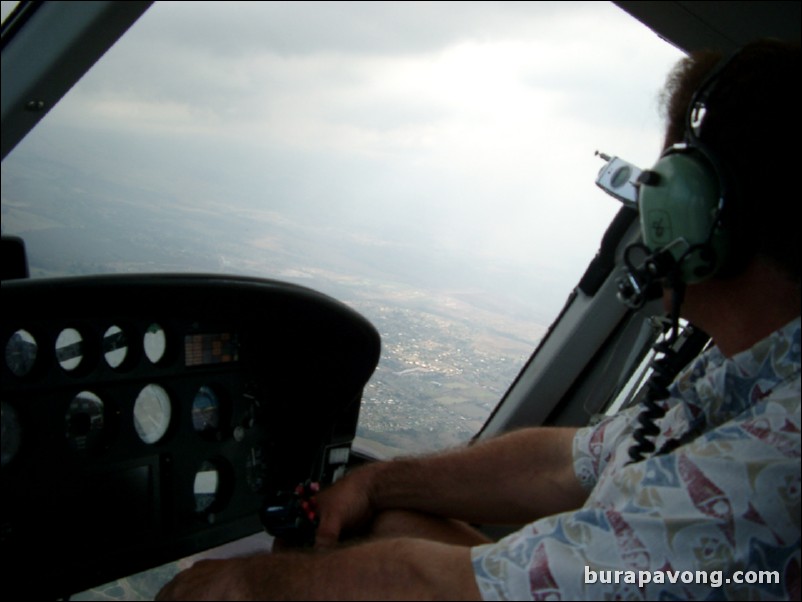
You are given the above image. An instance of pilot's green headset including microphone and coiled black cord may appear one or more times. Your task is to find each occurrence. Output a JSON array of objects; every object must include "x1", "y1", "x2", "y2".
[{"x1": 618, "y1": 58, "x2": 734, "y2": 464}]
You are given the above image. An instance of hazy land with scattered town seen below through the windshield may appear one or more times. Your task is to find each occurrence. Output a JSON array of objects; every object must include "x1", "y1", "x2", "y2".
[{"x1": 3, "y1": 153, "x2": 544, "y2": 454}]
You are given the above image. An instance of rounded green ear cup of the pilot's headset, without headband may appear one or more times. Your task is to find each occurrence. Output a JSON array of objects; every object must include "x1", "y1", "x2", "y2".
[{"x1": 639, "y1": 145, "x2": 729, "y2": 284}]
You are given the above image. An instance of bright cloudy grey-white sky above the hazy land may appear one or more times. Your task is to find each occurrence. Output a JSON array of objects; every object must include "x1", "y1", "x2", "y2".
[{"x1": 3, "y1": 2, "x2": 681, "y2": 322}]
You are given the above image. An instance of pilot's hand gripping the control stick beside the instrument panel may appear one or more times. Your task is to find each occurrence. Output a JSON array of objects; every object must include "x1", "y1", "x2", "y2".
[{"x1": 315, "y1": 464, "x2": 380, "y2": 549}]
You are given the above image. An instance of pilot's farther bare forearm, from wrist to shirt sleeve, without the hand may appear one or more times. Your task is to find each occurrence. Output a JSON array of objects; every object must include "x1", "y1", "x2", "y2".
[{"x1": 365, "y1": 428, "x2": 586, "y2": 523}]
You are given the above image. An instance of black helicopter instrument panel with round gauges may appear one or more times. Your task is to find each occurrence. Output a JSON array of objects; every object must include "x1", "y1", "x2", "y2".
[{"x1": 0, "y1": 275, "x2": 380, "y2": 597}]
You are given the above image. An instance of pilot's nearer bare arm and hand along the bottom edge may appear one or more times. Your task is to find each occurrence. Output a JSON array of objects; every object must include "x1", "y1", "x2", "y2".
[{"x1": 156, "y1": 539, "x2": 481, "y2": 600}]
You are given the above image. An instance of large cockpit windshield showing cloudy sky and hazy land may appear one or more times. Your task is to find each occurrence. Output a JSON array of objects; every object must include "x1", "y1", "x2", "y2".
[{"x1": 2, "y1": 2, "x2": 680, "y2": 456}]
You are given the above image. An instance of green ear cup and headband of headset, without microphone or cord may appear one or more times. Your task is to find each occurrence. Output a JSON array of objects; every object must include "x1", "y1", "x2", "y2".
[{"x1": 638, "y1": 57, "x2": 735, "y2": 284}]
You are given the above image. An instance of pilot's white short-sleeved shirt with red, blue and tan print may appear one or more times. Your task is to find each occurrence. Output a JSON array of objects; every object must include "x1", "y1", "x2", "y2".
[{"x1": 472, "y1": 318, "x2": 802, "y2": 600}]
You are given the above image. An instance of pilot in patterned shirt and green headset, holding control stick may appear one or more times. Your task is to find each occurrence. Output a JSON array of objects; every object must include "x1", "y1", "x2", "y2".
[{"x1": 160, "y1": 41, "x2": 802, "y2": 600}]
